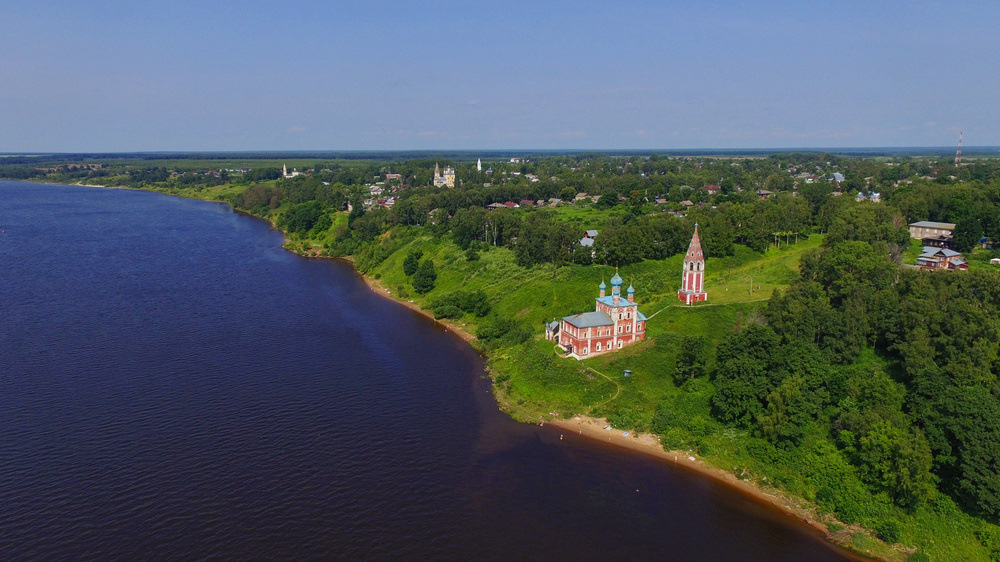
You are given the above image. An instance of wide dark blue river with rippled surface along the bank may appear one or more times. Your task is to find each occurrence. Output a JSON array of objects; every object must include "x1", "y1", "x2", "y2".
[{"x1": 0, "y1": 182, "x2": 841, "y2": 560}]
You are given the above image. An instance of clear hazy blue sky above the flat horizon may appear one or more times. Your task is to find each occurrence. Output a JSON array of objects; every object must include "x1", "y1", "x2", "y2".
[{"x1": 0, "y1": 0, "x2": 1000, "y2": 152}]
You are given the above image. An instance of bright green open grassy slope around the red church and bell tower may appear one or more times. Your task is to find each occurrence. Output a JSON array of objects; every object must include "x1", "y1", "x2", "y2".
[{"x1": 54, "y1": 180, "x2": 1000, "y2": 560}]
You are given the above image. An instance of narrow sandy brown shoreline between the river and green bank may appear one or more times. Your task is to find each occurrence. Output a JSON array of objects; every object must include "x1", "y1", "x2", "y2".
[{"x1": 21, "y1": 180, "x2": 873, "y2": 560}]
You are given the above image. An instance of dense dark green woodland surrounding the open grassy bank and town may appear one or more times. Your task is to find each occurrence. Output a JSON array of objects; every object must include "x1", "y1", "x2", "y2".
[{"x1": 0, "y1": 154, "x2": 1000, "y2": 558}]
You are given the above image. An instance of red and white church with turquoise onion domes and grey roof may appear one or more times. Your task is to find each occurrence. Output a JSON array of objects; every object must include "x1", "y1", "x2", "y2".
[{"x1": 558, "y1": 272, "x2": 646, "y2": 359}]
